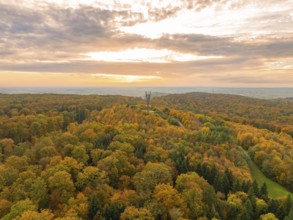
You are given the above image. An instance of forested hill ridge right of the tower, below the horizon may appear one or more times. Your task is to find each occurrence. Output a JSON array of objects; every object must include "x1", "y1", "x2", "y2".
[{"x1": 153, "y1": 93, "x2": 293, "y2": 136}]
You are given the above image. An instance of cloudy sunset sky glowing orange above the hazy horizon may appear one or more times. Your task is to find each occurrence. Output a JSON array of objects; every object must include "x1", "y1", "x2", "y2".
[{"x1": 0, "y1": 0, "x2": 293, "y2": 87}]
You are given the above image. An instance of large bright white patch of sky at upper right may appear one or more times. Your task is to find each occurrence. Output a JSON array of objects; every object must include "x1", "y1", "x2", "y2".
[{"x1": 120, "y1": 3, "x2": 293, "y2": 38}]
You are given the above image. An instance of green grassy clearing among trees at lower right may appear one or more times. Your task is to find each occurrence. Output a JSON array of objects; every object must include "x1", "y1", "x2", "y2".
[{"x1": 247, "y1": 160, "x2": 293, "y2": 198}]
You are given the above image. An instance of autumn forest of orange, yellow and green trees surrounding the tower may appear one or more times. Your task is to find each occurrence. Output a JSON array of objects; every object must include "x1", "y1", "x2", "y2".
[{"x1": 0, "y1": 93, "x2": 293, "y2": 220}]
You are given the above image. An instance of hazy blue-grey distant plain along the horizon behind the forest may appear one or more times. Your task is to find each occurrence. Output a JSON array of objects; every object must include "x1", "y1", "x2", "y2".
[{"x1": 0, "y1": 86, "x2": 293, "y2": 99}]
